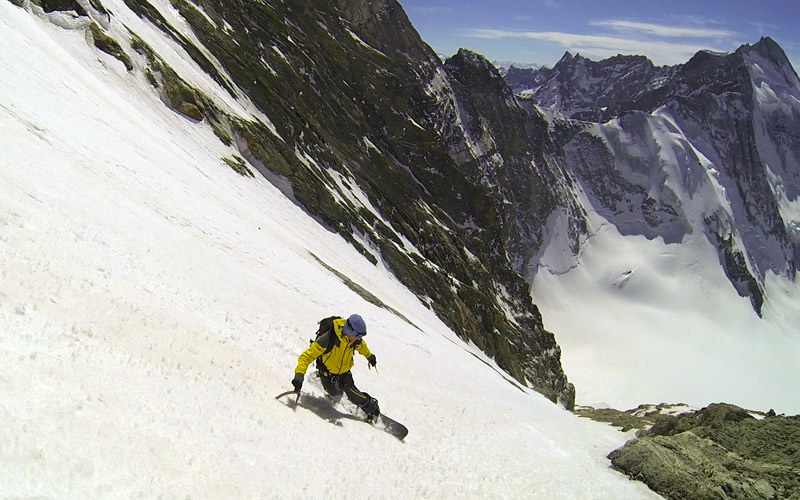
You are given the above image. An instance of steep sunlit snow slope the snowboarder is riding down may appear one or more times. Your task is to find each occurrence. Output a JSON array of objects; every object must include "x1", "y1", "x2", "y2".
[{"x1": 0, "y1": 1, "x2": 657, "y2": 499}]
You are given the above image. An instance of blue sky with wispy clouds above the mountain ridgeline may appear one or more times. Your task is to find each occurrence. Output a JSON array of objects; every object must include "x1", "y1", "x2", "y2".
[{"x1": 399, "y1": 0, "x2": 800, "y2": 70}]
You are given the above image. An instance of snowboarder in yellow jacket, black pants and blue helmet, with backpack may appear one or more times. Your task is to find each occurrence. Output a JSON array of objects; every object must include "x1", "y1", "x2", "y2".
[{"x1": 292, "y1": 314, "x2": 380, "y2": 422}]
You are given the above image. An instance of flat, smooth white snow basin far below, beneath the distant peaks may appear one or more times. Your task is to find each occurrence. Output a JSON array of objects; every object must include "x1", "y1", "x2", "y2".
[{"x1": 533, "y1": 206, "x2": 800, "y2": 414}]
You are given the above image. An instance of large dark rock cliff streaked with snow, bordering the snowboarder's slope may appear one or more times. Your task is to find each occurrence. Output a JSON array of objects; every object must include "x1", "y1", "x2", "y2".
[{"x1": 10, "y1": 0, "x2": 575, "y2": 408}]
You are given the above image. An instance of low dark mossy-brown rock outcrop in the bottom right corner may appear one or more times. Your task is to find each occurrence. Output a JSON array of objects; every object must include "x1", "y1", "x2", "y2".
[{"x1": 609, "y1": 404, "x2": 800, "y2": 499}]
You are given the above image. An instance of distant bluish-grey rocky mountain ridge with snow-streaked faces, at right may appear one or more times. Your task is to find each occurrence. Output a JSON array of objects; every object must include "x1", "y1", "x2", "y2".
[{"x1": 507, "y1": 38, "x2": 800, "y2": 314}]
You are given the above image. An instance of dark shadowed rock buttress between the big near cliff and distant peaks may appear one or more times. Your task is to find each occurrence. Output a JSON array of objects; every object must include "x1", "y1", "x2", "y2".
[{"x1": 438, "y1": 49, "x2": 582, "y2": 284}]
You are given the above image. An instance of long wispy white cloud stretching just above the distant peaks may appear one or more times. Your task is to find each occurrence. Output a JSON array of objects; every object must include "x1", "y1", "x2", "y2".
[{"x1": 468, "y1": 29, "x2": 725, "y2": 64}]
